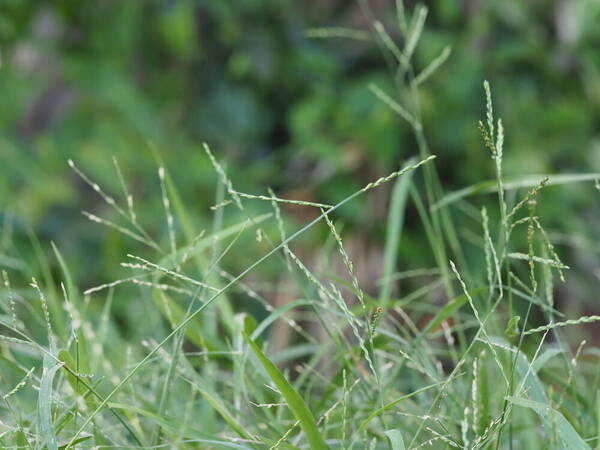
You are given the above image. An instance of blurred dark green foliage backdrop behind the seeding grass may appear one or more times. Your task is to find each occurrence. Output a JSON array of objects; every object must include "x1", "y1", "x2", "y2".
[{"x1": 0, "y1": 0, "x2": 600, "y2": 328}]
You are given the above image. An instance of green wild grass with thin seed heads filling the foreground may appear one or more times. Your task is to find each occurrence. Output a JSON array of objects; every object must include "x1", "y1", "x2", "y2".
[{"x1": 0, "y1": 2, "x2": 600, "y2": 450}]
